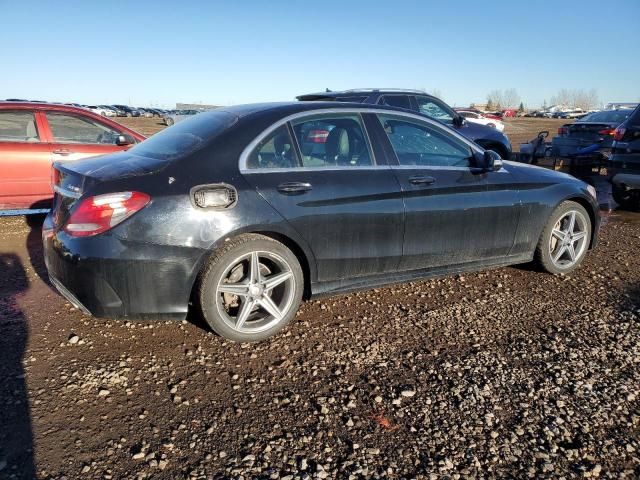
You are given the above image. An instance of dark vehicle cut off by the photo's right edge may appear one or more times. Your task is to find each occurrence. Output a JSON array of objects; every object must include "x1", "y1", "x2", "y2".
[{"x1": 607, "y1": 107, "x2": 640, "y2": 209}]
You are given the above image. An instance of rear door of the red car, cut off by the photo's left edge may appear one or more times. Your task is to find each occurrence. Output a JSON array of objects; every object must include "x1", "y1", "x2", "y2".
[{"x1": 0, "y1": 110, "x2": 52, "y2": 210}]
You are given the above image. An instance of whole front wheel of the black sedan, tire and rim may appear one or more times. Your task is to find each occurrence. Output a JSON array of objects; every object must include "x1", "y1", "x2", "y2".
[{"x1": 534, "y1": 201, "x2": 593, "y2": 275}]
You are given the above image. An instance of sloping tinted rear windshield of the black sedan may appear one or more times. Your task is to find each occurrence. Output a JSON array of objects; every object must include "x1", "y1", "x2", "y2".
[{"x1": 129, "y1": 110, "x2": 238, "y2": 161}]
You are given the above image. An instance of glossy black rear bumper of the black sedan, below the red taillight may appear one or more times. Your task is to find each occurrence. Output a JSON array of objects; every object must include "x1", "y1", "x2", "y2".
[{"x1": 42, "y1": 216, "x2": 203, "y2": 319}]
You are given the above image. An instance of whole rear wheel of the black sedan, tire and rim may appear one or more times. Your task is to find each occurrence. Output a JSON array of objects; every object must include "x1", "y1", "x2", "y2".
[{"x1": 198, "y1": 234, "x2": 304, "y2": 342}]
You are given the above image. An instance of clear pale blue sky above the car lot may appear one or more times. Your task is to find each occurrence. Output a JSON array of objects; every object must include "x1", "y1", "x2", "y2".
[{"x1": 0, "y1": 0, "x2": 640, "y2": 108}]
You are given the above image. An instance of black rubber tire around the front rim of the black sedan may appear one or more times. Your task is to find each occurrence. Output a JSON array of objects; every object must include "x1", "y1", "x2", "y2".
[{"x1": 534, "y1": 201, "x2": 593, "y2": 275}]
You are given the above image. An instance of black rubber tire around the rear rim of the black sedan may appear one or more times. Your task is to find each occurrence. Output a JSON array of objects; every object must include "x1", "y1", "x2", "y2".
[{"x1": 200, "y1": 237, "x2": 304, "y2": 342}]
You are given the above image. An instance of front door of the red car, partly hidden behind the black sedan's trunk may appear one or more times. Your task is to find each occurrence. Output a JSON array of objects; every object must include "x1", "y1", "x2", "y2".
[{"x1": 46, "y1": 111, "x2": 130, "y2": 162}]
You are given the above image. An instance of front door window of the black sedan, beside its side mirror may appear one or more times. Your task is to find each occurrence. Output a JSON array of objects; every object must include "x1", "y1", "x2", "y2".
[{"x1": 378, "y1": 115, "x2": 472, "y2": 167}]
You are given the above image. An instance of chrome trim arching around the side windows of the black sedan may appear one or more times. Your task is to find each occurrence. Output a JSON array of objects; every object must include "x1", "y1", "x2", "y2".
[{"x1": 238, "y1": 107, "x2": 482, "y2": 174}]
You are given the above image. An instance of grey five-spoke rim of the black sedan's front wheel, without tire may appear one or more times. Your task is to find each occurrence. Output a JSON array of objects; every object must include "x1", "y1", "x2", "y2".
[{"x1": 549, "y1": 210, "x2": 589, "y2": 269}]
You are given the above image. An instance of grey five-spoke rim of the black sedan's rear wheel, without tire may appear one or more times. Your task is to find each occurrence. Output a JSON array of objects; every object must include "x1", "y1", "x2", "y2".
[{"x1": 216, "y1": 251, "x2": 295, "y2": 333}]
